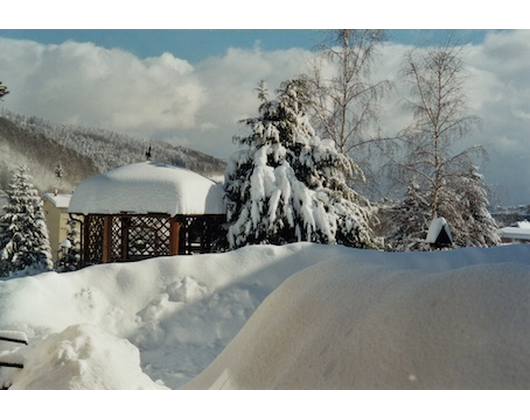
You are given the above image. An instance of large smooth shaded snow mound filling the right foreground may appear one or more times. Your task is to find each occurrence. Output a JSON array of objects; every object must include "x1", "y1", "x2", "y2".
[{"x1": 185, "y1": 247, "x2": 530, "y2": 389}]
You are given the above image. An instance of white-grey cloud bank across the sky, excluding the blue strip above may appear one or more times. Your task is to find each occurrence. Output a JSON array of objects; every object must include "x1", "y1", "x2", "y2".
[{"x1": 0, "y1": 30, "x2": 530, "y2": 203}]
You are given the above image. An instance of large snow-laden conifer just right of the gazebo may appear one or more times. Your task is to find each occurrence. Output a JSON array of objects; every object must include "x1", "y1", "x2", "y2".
[{"x1": 225, "y1": 79, "x2": 378, "y2": 248}]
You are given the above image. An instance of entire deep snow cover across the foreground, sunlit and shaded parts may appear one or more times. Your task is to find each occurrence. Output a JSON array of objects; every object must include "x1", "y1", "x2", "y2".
[{"x1": 0, "y1": 243, "x2": 530, "y2": 389}]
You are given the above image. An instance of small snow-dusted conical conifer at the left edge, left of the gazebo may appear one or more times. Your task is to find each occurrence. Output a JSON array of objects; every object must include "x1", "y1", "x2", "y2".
[{"x1": 0, "y1": 166, "x2": 53, "y2": 276}]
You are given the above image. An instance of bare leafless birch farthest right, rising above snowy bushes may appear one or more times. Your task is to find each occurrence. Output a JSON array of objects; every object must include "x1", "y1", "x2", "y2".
[{"x1": 402, "y1": 40, "x2": 483, "y2": 218}]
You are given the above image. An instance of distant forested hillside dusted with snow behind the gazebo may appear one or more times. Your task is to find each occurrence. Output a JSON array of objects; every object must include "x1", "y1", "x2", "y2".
[{"x1": 0, "y1": 109, "x2": 226, "y2": 192}]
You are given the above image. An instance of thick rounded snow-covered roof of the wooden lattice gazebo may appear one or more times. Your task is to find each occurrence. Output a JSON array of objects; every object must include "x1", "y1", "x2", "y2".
[{"x1": 69, "y1": 162, "x2": 225, "y2": 216}]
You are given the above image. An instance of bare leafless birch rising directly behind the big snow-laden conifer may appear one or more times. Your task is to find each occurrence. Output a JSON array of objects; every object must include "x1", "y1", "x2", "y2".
[{"x1": 307, "y1": 29, "x2": 391, "y2": 173}]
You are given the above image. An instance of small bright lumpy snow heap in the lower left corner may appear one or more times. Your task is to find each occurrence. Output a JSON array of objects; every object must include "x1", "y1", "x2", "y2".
[{"x1": 10, "y1": 325, "x2": 165, "y2": 390}]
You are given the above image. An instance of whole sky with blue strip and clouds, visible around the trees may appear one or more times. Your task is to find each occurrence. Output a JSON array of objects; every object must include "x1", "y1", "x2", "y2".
[{"x1": 0, "y1": 24, "x2": 530, "y2": 204}]
